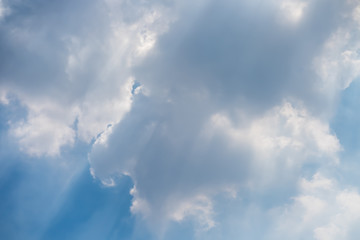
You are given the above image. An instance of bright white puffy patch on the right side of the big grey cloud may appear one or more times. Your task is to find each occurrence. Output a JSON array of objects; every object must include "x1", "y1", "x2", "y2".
[{"x1": 205, "y1": 101, "x2": 340, "y2": 155}]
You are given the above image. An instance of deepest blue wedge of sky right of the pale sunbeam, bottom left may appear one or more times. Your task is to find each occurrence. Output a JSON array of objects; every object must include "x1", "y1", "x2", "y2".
[{"x1": 42, "y1": 168, "x2": 134, "y2": 239}]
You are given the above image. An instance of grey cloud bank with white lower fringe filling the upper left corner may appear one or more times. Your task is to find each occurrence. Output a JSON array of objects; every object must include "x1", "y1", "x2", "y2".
[{"x1": 0, "y1": 0, "x2": 171, "y2": 156}]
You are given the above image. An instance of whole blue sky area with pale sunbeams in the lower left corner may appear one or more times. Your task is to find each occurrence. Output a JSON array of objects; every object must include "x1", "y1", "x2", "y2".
[{"x1": 0, "y1": 102, "x2": 141, "y2": 239}]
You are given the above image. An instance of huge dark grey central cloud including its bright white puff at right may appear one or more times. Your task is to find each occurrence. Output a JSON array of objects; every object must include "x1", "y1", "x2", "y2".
[{"x1": 90, "y1": 1, "x2": 354, "y2": 233}]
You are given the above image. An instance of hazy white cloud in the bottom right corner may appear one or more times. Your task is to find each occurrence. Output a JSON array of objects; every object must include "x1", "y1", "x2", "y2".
[{"x1": 273, "y1": 173, "x2": 360, "y2": 240}]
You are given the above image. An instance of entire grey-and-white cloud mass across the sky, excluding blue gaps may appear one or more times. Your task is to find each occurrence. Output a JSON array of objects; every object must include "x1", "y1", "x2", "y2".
[{"x1": 0, "y1": 0, "x2": 360, "y2": 240}]
